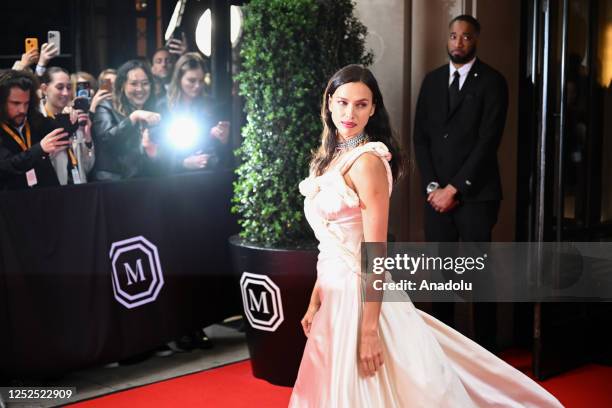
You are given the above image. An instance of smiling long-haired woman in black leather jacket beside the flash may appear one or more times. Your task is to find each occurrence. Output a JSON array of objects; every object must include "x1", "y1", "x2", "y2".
[{"x1": 93, "y1": 60, "x2": 160, "y2": 181}]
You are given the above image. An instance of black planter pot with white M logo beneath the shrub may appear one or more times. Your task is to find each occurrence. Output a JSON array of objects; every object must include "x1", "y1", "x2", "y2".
[{"x1": 230, "y1": 236, "x2": 318, "y2": 386}]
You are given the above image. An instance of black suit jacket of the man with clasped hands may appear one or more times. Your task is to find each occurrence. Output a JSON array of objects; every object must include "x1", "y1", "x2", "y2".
[{"x1": 414, "y1": 59, "x2": 508, "y2": 201}]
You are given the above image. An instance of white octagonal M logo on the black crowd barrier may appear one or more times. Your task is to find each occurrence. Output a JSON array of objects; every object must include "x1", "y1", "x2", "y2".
[{"x1": 109, "y1": 236, "x2": 164, "y2": 309}]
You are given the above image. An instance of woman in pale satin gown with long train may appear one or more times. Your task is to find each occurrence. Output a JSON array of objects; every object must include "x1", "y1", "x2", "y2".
[{"x1": 289, "y1": 65, "x2": 562, "y2": 408}]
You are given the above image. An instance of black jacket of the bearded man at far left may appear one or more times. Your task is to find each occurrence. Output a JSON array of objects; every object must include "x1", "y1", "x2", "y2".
[{"x1": 0, "y1": 113, "x2": 59, "y2": 190}]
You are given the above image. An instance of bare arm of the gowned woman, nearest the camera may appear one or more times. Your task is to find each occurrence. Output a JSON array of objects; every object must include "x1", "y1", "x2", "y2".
[{"x1": 347, "y1": 153, "x2": 389, "y2": 376}]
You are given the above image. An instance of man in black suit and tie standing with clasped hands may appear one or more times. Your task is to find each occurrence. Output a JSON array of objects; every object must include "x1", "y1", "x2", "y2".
[{"x1": 414, "y1": 15, "x2": 508, "y2": 347}]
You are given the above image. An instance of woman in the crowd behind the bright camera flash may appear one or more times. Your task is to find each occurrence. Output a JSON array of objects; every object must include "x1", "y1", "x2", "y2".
[{"x1": 159, "y1": 52, "x2": 230, "y2": 171}]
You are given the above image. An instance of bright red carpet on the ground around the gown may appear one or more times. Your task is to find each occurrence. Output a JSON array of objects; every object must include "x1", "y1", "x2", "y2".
[{"x1": 71, "y1": 352, "x2": 612, "y2": 408}]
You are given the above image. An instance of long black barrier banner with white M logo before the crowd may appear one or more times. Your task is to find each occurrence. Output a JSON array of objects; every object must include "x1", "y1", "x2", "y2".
[{"x1": 0, "y1": 171, "x2": 241, "y2": 378}]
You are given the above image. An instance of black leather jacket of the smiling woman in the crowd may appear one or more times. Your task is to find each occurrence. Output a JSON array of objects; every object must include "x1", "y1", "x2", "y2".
[{"x1": 92, "y1": 101, "x2": 157, "y2": 179}]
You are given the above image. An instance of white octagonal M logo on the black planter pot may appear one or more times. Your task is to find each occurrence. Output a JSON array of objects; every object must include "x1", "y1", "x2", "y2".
[{"x1": 240, "y1": 272, "x2": 285, "y2": 332}]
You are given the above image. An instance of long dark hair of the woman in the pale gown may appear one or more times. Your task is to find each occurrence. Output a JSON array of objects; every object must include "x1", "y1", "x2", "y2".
[{"x1": 310, "y1": 64, "x2": 402, "y2": 181}]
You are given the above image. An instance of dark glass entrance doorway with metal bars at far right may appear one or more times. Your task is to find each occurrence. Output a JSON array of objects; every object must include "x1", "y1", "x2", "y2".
[{"x1": 517, "y1": 0, "x2": 612, "y2": 378}]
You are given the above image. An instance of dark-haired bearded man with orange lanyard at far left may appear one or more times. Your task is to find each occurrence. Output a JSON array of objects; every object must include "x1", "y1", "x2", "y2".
[{"x1": 0, "y1": 70, "x2": 70, "y2": 190}]
